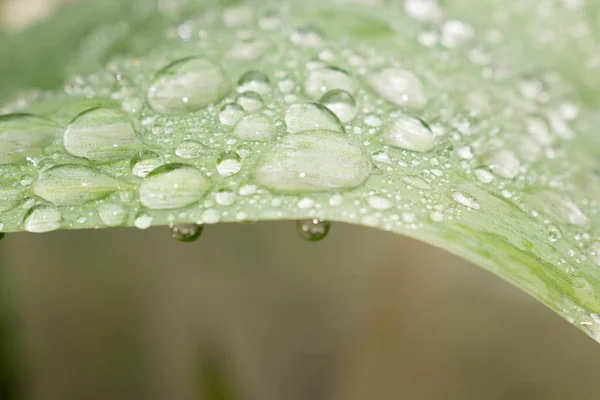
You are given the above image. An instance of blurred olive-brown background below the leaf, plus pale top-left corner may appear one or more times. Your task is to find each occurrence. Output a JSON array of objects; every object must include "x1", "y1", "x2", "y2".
[{"x1": 0, "y1": 0, "x2": 600, "y2": 400}]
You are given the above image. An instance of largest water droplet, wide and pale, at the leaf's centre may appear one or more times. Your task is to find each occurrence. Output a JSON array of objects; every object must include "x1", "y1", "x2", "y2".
[{"x1": 255, "y1": 130, "x2": 372, "y2": 193}]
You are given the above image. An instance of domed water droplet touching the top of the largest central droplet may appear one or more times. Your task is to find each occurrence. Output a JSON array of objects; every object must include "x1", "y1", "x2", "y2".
[{"x1": 285, "y1": 103, "x2": 344, "y2": 133}]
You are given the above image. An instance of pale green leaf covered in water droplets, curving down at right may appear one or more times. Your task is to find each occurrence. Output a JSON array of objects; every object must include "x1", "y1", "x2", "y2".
[{"x1": 0, "y1": 0, "x2": 600, "y2": 341}]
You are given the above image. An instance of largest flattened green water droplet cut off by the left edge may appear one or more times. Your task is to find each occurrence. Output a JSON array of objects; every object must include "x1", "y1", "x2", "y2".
[{"x1": 0, "y1": 114, "x2": 62, "y2": 165}]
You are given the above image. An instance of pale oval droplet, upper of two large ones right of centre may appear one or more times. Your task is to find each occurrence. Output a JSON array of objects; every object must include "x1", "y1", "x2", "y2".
[{"x1": 367, "y1": 68, "x2": 427, "y2": 110}]
